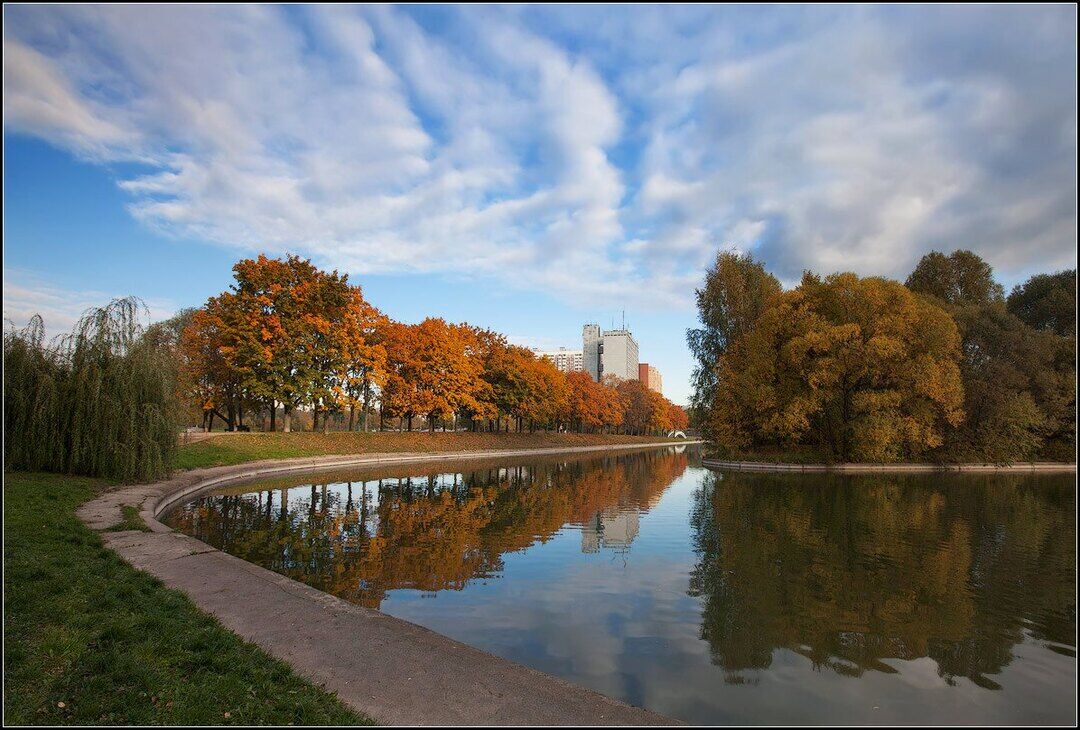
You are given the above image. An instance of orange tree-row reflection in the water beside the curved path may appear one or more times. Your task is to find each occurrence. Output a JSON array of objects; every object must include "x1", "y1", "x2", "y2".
[{"x1": 166, "y1": 450, "x2": 688, "y2": 608}]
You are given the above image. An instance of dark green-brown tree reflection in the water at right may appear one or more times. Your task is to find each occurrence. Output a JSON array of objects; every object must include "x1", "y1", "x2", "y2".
[{"x1": 689, "y1": 473, "x2": 1076, "y2": 689}]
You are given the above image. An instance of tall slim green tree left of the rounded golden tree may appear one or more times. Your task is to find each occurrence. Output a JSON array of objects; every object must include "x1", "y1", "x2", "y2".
[{"x1": 686, "y1": 251, "x2": 781, "y2": 418}]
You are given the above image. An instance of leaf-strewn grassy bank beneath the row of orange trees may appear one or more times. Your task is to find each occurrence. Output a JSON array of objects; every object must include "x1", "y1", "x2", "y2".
[{"x1": 175, "y1": 431, "x2": 670, "y2": 469}]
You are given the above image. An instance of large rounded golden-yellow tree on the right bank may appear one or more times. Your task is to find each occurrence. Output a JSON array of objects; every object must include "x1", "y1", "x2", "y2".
[{"x1": 707, "y1": 273, "x2": 963, "y2": 461}]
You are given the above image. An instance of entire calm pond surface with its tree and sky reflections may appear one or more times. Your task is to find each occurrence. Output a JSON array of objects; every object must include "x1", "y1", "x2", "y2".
[{"x1": 166, "y1": 450, "x2": 1076, "y2": 724}]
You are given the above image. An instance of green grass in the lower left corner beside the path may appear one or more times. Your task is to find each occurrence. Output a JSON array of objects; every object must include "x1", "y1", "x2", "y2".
[{"x1": 3, "y1": 473, "x2": 369, "y2": 725}]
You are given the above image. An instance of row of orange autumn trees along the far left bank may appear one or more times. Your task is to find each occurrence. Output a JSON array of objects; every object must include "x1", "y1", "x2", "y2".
[{"x1": 171, "y1": 256, "x2": 687, "y2": 434}]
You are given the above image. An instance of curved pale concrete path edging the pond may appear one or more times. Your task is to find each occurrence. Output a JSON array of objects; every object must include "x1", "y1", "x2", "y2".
[{"x1": 79, "y1": 441, "x2": 694, "y2": 725}]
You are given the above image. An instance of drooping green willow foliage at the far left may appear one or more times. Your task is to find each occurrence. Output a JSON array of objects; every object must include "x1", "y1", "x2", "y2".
[{"x1": 3, "y1": 298, "x2": 177, "y2": 482}]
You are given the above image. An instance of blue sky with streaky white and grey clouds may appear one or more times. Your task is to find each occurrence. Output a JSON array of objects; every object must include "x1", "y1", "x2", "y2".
[{"x1": 3, "y1": 4, "x2": 1077, "y2": 403}]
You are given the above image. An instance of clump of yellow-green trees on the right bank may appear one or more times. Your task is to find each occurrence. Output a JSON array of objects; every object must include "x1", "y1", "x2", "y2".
[{"x1": 688, "y1": 251, "x2": 1076, "y2": 463}]
